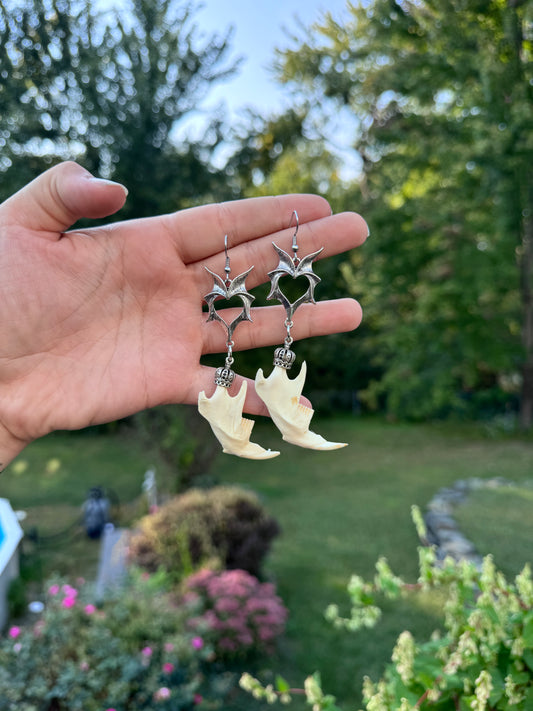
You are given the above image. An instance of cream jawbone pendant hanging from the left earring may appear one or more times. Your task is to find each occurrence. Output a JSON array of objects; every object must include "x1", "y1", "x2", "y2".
[{"x1": 198, "y1": 381, "x2": 279, "y2": 459}]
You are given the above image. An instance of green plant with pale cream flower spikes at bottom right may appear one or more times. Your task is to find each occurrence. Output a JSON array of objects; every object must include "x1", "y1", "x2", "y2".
[{"x1": 241, "y1": 507, "x2": 533, "y2": 711}]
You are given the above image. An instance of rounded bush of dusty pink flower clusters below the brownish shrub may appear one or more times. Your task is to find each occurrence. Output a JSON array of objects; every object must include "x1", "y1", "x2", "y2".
[{"x1": 184, "y1": 570, "x2": 287, "y2": 657}]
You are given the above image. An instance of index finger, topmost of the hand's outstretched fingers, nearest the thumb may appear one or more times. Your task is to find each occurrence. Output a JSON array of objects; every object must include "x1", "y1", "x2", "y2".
[{"x1": 167, "y1": 195, "x2": 331, "y2": 264}]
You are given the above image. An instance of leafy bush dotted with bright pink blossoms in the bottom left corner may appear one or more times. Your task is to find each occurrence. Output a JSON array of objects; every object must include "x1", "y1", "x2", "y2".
[{"x1": 0, "y1": 577, "x2": 235, "y2": 711}]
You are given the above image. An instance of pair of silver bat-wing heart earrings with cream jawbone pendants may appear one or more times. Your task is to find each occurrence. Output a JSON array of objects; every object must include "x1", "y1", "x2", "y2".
[{"x1": 198, "y1": 211, "x2": 346, "y2": 459}]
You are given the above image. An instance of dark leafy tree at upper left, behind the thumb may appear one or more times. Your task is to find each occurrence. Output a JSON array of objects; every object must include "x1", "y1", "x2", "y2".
[{"x1": 0, "y1": 0, "x2": 236, "y2": 217}]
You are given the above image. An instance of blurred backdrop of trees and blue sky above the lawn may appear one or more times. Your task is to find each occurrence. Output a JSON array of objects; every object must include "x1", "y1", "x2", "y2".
[{"x1": 0, "y1": 0, "x2": 533, "y2": 429}]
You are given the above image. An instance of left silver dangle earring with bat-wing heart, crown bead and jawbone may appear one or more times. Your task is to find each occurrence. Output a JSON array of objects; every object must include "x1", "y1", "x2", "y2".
[{"x1": 198, "y1": 235, "x2": 279, "y2": 459}]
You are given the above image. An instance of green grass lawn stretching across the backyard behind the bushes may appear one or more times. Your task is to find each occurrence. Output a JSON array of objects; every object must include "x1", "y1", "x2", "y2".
[{"x1": 0, "y1": 417, "x2": 533, "y2": 709}]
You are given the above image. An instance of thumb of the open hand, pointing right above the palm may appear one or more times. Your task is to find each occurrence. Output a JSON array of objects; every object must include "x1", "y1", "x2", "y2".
[{"x1": 2, "y1": 162, "x2": 128, "y2": 239}]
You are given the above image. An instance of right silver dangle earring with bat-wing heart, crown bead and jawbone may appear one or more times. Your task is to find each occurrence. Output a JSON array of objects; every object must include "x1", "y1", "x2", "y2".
[{"x1": 255, "y1": 210, "x2": 346, "y2": 450}]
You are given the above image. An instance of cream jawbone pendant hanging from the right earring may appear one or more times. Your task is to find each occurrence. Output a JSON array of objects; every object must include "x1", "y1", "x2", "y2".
[{"x1": 255, "y1": 363, "x2": 347, "y2": 450}]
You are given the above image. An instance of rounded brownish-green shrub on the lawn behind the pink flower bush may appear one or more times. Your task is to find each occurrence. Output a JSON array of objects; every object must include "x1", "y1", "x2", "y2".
[{"x1": 130, "y1": 486, "x2": 280, "y2": 579}]
